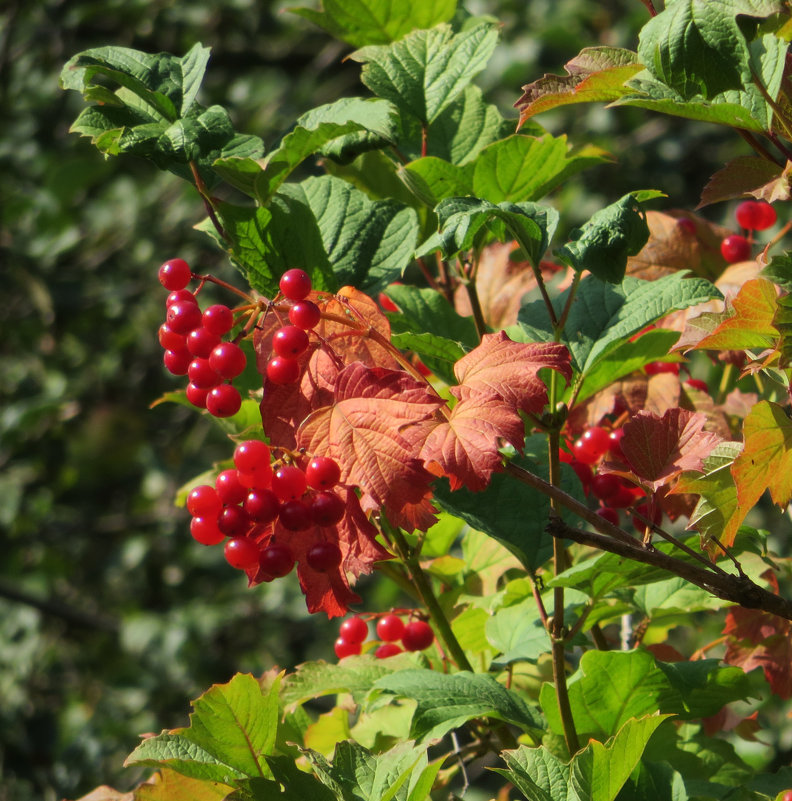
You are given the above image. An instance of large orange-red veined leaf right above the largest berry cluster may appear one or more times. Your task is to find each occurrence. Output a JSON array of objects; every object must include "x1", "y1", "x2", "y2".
[{"x1": 297, "y1": 362, "x2": 444, "y2": 509}]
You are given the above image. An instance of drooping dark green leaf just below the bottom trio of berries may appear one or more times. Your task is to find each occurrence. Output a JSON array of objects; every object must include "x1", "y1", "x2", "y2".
[{"x1": 374, "y1": 670, "x2": 544, "y2": 740}]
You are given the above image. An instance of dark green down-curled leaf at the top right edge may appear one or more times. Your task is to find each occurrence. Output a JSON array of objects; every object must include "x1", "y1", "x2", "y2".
[{"x1": 638, "y1": 0, "x2": 782, "y2": 100}]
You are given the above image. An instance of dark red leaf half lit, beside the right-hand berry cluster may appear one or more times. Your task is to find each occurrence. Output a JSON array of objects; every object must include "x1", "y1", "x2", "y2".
[{"x1": 619, "y1": 408, "x2": 720, "y2": 492}]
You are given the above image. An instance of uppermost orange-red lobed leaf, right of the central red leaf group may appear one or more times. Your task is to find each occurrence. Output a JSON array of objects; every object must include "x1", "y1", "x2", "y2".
[{"x1": 454, "y1": 331, "x2": 572, "y2": 414}]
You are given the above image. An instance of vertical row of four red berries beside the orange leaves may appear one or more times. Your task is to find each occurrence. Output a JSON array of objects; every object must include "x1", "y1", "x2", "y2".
[{"x1": 267, "y1": 269, "x2": 321, "y2": 384}]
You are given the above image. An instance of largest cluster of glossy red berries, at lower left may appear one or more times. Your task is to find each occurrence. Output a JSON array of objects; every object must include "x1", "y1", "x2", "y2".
[{"x1": 187, "y1": 440, "x2": 346, "y2": 580}]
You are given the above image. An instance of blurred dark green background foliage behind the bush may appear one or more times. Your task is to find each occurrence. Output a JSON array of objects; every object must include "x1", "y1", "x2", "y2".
[{"x1": 0, "y1": 0, "x2": 764, "y2": 801}]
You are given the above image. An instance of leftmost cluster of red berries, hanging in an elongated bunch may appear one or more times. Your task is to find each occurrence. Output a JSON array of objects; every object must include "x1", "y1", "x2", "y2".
[{"x1": 159, "y1": 259, "x2": 247, "y2": 417}]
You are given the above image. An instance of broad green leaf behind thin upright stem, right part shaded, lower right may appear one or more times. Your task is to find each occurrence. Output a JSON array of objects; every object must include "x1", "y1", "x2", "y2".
[{"x1": 540, "y1": 650, "x2": 756, "y2": 738}]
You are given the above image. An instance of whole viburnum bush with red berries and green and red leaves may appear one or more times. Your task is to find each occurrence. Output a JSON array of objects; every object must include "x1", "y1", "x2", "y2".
[{"x1": 62, "y1": 0, "x2": 792, "y2": 801}]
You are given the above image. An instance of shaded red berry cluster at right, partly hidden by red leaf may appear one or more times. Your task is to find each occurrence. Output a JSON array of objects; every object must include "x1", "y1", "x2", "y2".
[{"x1": 561, "y1": 422, "x2": 664, "y2": 533}]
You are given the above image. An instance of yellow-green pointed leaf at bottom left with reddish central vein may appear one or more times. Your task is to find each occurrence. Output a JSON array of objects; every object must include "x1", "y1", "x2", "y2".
[{"x1": 125, "y1": 673, "x2": 280, "y2": 782}]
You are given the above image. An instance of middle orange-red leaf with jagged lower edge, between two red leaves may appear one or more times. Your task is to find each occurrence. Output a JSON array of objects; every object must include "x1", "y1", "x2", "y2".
[{"x1": 421, "y1": 385, "x2": 525, "y2": 492}]
